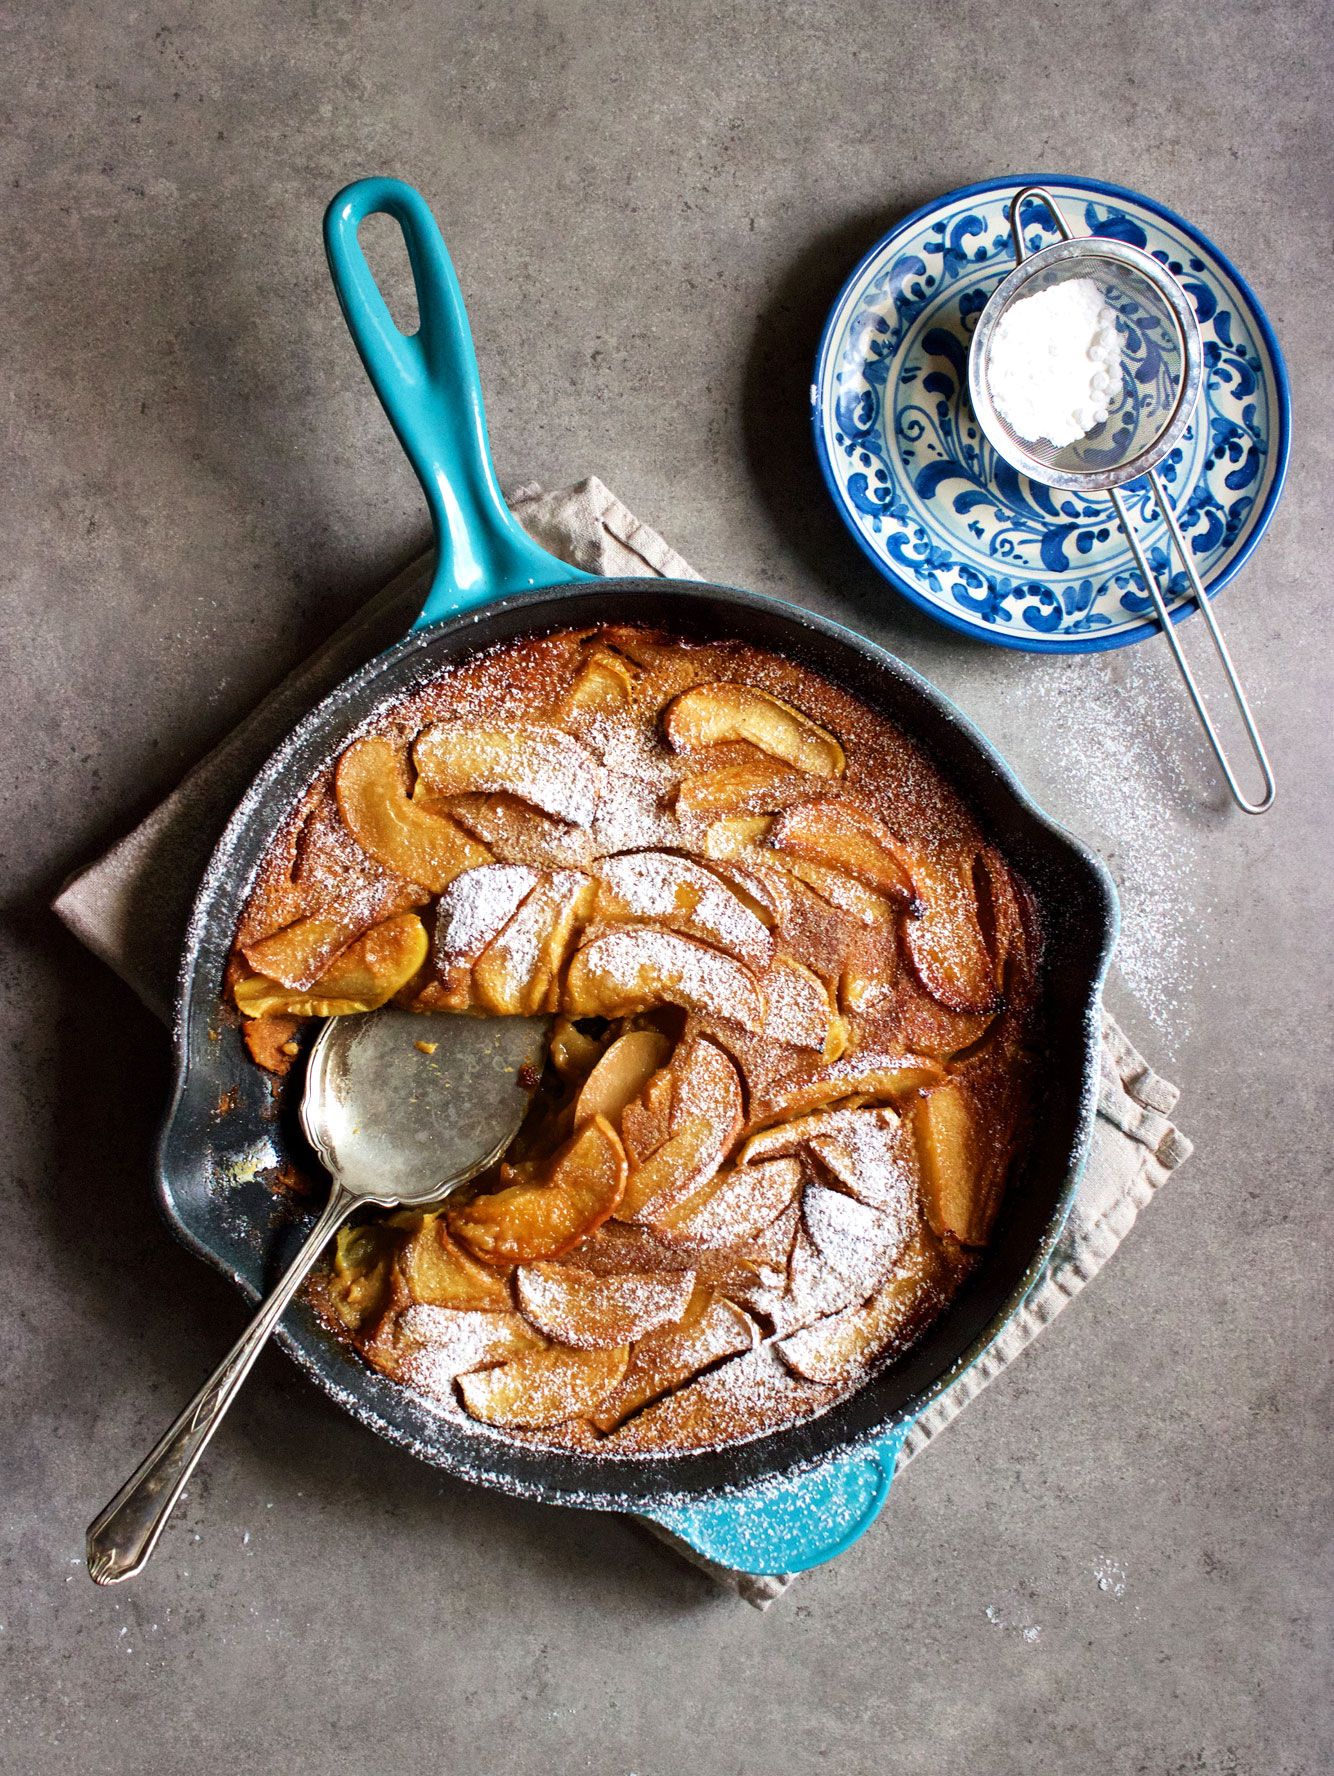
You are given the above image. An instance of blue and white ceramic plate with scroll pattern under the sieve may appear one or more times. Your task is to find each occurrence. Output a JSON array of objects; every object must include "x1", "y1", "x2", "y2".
[{"x1": 810, "y1": 174, "x2": 1291, "y2": 652}]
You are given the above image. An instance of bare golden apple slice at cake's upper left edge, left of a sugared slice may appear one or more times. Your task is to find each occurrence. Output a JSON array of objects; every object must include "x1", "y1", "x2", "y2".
[{"x1": 334, "y1": 735, "x2": 490, "y2": 893}]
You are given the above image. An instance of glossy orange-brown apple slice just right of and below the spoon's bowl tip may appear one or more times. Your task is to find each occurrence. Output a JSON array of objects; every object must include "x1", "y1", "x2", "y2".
[{"x1": 446, "y1": 1117, "x2": 625, "y2": 1265}]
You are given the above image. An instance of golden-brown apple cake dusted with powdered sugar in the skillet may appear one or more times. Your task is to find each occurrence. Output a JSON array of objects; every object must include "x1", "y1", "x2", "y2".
[{"x1": 227, "y1": 627, "x2": 1041, "y2": 1456}]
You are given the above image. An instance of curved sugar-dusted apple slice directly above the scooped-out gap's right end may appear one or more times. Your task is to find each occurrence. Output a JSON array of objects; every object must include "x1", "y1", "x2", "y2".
[{"x1": 565, "y1": 925, "x2": 764, "y2": 1030}]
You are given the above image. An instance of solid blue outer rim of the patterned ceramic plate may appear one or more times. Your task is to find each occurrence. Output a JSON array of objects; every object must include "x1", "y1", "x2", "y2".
[{"x1": 810, "y1": 174, "x2": 1291, "y2": 654}]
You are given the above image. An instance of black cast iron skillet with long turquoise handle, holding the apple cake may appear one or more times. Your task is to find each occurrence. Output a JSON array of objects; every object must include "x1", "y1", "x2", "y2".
[{"x1": 158, "y1": 179, "x2": 1117, "y2": 1541}]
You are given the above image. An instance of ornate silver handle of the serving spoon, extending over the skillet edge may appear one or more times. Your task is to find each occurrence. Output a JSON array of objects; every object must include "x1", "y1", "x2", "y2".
[{"x1": 87, "y1": 1185, "x2": 359, "y2": 1584}]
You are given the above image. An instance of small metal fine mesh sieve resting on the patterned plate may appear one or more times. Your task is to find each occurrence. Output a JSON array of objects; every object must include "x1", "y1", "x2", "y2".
[{"x1": 968, "y1": 185, "x2": 1274, "y2": 813}]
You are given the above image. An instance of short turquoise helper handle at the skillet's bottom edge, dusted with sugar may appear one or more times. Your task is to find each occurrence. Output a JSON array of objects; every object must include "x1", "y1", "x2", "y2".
[{"x1": 645, "y1": 1424, "x2": 909, "y2": 1574}]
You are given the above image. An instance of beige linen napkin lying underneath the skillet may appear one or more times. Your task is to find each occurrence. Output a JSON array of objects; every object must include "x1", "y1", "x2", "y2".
[{"x1": 55, "y1": 478, "x2": 1190, "y2": 1609}]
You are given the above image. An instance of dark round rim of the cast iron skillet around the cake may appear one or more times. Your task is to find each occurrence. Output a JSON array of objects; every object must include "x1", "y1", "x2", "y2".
[{"x1": 156, "y1": 579, "x2": 1119, "y2": 1510}]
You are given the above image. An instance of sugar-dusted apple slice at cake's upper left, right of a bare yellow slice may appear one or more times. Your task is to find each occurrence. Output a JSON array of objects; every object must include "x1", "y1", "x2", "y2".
[{"x1": 412, "y1": 721, "x2": 599, "y2": 826}]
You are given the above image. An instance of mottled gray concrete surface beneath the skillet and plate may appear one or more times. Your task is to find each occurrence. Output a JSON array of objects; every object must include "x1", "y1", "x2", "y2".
[{"x1": 0, "y1": 0, "x2": 1334, "y2": 1776}]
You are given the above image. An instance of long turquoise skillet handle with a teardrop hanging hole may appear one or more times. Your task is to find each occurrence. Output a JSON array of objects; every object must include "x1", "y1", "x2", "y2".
[{"x1": 325, "y1": 179, "x2": 593, "y2": 629}]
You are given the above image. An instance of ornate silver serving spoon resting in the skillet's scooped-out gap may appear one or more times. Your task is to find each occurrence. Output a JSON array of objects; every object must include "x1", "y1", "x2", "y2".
[{"x1": 87, "y1": 1005, "x2": 551, "y2": 1584}]
